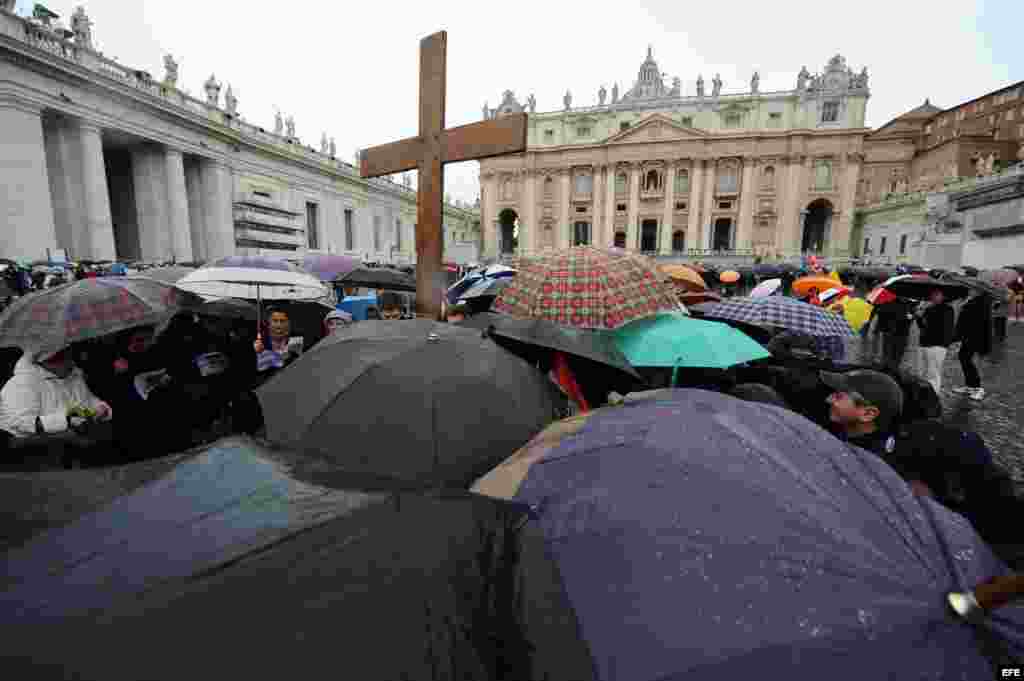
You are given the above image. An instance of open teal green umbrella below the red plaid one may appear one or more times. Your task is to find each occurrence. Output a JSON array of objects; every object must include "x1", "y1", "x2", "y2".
[{"x1": 613, "y1": 314, "x2": 771, "y2": 381}]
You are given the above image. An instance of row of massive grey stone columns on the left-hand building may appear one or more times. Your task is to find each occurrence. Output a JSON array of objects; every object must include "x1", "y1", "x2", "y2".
[{"x1": 0, "y1": 95, "x2": 234, "y2": 262}]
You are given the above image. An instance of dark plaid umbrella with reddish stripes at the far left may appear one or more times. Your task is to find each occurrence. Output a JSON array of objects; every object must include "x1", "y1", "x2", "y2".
[{"x1": 0, "y1": 276, "x2": 203, "y2": 357}]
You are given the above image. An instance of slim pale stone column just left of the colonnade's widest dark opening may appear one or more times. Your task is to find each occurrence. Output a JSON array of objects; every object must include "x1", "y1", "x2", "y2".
[{"x1": 79, "y1": 121, "x2": 117, "y2": 260}]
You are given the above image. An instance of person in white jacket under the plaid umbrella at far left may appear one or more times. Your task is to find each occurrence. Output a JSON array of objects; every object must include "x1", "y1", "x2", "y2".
[{"x1": 0, "y1": 348, "x2": 114, "y2": 437}]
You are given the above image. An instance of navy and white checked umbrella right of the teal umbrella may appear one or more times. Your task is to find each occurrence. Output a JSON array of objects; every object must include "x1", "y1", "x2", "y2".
[{"x1": 705, "y1": 296, "x2": 855, "y2": 337}]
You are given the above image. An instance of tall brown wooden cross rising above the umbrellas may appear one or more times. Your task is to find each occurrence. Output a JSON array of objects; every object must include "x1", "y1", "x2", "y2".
[{"x1": 359, "y1": 31, "x2": 526, "y2": 318}]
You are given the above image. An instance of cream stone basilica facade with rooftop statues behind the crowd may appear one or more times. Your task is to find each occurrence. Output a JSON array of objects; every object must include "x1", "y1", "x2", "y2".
[{"x1": 480, "y1": 49, "x2": 869, "y2": 257}]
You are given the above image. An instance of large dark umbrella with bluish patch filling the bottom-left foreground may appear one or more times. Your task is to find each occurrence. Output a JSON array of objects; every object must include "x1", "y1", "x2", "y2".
[{"x1": 0, "y1": 438, "x2": 594, "y2": 681}]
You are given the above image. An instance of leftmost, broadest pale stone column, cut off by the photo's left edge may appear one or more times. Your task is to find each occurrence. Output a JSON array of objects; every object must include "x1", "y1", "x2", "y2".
[{"x1": 0, "y1": 95, "x2": 57, "y2": 260}]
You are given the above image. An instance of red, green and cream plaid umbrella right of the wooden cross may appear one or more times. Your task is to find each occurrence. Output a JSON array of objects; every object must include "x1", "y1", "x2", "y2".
[{"x1": 492, "y1": 246, "x2": 679, "y2": 329}]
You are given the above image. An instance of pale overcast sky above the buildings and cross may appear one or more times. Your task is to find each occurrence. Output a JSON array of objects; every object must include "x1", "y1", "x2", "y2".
[{"x1": 19, "y1": 0, "x2": 1024, "y2": 201}]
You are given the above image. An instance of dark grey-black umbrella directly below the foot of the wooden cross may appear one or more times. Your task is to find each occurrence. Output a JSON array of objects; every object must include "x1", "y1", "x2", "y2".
[{"x1": 257, "y1": 320, "x2": 559, "y2": 487}]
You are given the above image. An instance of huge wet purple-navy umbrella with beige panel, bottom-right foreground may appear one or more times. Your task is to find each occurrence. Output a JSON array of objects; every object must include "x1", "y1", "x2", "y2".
[{"x1": 473, "y1": 390, "x2": 1024, "y2": 681}]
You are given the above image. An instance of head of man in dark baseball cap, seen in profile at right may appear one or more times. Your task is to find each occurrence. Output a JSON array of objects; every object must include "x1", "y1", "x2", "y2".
[{"x1": 820, "y1": 369, "x2": 903, "y2": 457}]
